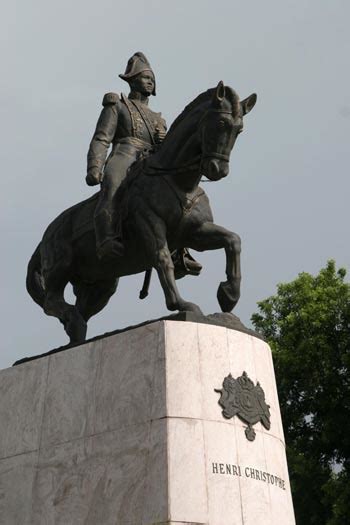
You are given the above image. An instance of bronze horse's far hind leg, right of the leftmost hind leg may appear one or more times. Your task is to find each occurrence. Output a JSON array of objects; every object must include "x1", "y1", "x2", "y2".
[{"x1": 73, "y1": 279, "x2": 118, "y2": 322}]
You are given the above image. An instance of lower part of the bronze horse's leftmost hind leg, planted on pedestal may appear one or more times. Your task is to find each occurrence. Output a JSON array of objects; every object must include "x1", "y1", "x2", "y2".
[{"x1": 43, "y1": 279, "x2": 87, "y2": 343}]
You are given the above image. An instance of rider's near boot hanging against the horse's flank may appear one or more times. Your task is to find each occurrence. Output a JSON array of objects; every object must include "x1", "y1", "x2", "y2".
[{"x1": 95, "y1": 210, "x2": 124, "y2": 259}]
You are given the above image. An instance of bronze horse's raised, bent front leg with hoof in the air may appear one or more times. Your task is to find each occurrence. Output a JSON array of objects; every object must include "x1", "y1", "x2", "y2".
[{"x1": 188, "y1": 222, "x2": 241, "y2": 312}]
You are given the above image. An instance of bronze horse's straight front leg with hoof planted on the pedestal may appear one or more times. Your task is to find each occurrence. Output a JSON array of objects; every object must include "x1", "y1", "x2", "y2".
[{"x1": 140, "y1": 215, "x2": 202, "y2": 314}]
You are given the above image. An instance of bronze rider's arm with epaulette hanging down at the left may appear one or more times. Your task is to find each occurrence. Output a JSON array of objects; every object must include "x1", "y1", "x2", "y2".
[{"x1": 86, "y1": 93, "x2": 119, "y2": 186}]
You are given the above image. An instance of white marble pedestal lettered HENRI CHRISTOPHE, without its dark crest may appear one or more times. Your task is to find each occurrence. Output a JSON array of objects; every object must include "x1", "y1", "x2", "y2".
[{"x1": 0, "y1": 321, "x2": 295, "y2": 525}]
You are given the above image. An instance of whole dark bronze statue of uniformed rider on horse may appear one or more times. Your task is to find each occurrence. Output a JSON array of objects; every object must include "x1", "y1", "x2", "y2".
[{"x1": 26, "y1": 52, "x2": 256, "y2": 343}]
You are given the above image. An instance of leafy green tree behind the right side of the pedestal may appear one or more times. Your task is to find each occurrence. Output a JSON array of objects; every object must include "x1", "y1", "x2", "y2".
[{"x1": 252, "y1": 261, "x2": 350, "y2": 525}]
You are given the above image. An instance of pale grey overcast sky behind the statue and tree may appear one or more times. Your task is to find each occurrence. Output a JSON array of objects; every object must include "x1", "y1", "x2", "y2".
[{"x1": 0, "y1": 0, "x2": 350, "y2": 368}]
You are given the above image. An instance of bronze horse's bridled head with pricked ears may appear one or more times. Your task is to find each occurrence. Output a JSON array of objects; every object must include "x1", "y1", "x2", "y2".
[{"x1": 198, "y1": 81, "x2": 256, "y2": 181}]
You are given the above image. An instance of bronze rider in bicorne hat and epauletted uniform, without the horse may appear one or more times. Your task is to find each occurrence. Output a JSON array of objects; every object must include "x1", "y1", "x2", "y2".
[{"x1": 86, "y1": 52, "x2": 202, "y2": 276}]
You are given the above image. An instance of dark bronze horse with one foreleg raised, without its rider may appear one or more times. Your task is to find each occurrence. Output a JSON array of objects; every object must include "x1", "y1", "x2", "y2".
[{"x1": 27, "y1": 82, "x2": 256, "y2": 343}]
